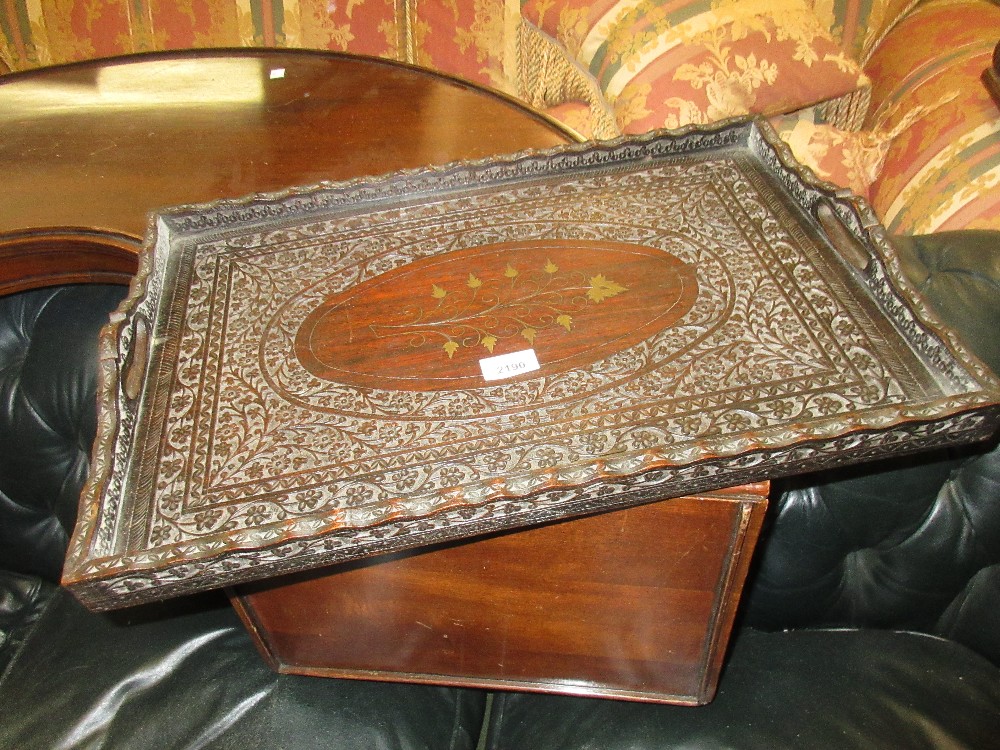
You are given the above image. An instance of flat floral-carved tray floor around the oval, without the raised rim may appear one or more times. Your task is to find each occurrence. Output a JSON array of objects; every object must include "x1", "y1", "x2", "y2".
[{"x1": 151, "y1": 160, "x2": 914, "y2": 544}]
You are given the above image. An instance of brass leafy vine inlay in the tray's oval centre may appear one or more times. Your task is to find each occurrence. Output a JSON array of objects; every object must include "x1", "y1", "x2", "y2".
[{"x1": 371, "y1": 260, "x2": 628, "y2": 359}]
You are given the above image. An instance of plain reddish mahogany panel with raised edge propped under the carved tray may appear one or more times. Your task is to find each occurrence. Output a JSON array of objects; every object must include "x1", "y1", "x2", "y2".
[{"x1": 232, "y1": 485, "x2": 767, "y2": 704}]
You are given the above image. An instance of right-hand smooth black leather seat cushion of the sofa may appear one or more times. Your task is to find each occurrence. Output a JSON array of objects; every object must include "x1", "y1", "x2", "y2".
[{"x1": 486, "y1": 629, "x2": 1000, "y2": 750}]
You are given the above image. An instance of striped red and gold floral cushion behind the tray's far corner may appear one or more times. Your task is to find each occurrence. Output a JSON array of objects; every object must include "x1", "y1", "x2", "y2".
[{"x1": 540, "y1": 0, "x2": 867, "y2": 133}]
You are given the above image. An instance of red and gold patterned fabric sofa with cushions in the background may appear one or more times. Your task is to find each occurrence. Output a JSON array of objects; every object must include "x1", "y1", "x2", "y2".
[{"x1": 0, "y1": 0, "x2": 1000, "y2": 234}]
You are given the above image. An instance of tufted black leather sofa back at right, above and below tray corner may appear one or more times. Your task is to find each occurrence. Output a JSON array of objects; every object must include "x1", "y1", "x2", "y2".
[{"x1": 746, "y1": 231, "x2": 1000, "y2": 663}]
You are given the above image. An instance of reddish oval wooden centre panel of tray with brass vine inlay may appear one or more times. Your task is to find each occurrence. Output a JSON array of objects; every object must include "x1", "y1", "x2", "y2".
[{"x1": 295, "y1": 240, "x2": 698, "y2": 391}]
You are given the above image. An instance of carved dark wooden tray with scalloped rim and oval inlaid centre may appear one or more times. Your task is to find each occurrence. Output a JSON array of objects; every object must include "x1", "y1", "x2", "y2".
[{"x1": 64, "y1": 122, "x2": 998, "y2": 608}]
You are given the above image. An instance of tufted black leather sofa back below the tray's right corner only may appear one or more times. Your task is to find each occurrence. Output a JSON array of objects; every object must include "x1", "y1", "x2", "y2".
[{"x1": 746, "y1": 448, "x2": 1000, "y2": 663}]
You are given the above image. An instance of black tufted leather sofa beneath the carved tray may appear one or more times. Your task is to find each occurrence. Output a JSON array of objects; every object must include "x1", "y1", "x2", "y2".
[{"x1": 0, "y1": 232, "x2": 1000, "y2": 750}]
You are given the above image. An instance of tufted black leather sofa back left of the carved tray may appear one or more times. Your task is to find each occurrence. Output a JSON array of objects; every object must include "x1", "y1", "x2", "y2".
[{"x1": 0, "y1": 285, "x2": 126, "y2": 581}]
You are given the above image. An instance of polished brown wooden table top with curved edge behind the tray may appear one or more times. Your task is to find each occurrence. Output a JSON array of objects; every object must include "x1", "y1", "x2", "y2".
[{"x1": 0, "y1": 50, "x2": 572, "y2": 293}]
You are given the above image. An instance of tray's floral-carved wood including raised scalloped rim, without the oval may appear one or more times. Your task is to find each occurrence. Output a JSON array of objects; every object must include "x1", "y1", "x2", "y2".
[{"x1": 67, "y1": 123, "x2": 996, "y2": 606}]
